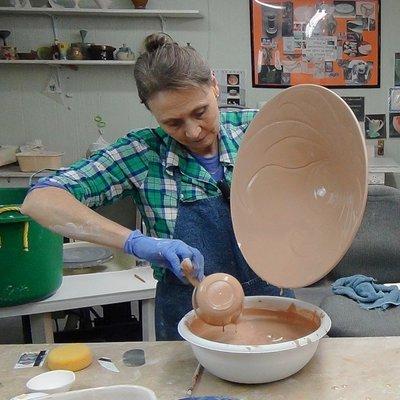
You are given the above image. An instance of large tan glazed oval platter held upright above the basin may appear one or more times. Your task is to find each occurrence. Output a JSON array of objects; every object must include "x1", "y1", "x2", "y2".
[{"x1": 231, "y1": 85, "x2": 367, "y2": 288}]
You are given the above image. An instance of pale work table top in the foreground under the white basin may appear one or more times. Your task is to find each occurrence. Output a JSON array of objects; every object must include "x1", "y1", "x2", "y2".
[{"x1": 0, "y1": 337, "x2": 400, "y2": 400}]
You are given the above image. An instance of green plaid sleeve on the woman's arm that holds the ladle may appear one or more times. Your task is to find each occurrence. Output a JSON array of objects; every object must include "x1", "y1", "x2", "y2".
[{"x1": 34, "y1": 130, "x2": 149, "y2": 207}]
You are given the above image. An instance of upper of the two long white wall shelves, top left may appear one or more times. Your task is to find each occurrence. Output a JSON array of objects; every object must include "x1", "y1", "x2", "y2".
[{"x1": 0, "y1": 7, "x2": 203, "y2": 18}]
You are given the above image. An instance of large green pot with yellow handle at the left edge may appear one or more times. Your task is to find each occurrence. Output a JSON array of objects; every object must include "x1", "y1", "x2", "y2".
[{"x1": 0, "y1": 188, "x2": 63, "y2": 313}]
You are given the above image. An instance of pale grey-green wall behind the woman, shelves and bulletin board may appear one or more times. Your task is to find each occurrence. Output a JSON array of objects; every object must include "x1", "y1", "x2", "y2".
[{"x1": 0, "y1": 0, "x2": 400, "y2": 175}]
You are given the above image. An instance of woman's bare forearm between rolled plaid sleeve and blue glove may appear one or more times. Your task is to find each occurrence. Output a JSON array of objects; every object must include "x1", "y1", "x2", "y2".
[{"x1": 21, "y1": 187, "x2": 131, "y2": 249}]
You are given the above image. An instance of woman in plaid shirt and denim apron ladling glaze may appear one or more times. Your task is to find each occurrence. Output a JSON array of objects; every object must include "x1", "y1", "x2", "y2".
[{"x1": 22, "y1": 34, "x2": 293, "y2": 340}]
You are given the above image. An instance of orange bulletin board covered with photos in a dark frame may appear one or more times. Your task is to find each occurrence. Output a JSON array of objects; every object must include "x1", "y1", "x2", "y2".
[{"x1": 250, "y1": 0, "x2": 381, "y2": 88}]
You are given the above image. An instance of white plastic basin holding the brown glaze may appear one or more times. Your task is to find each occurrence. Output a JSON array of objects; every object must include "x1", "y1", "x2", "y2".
[{"x1": 178, "y1": 296, "x2": 331, "y2": 383}]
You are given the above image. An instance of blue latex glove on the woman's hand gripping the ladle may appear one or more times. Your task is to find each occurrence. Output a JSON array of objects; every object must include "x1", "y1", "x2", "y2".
[{"x1": 124, "y1": 230, "x2": 204, "y2": 283}]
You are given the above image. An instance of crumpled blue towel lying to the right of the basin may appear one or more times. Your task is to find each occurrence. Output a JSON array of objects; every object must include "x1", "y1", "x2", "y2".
[{"x1": 332, "y1": 275, "x2": 400, "y2": 310}]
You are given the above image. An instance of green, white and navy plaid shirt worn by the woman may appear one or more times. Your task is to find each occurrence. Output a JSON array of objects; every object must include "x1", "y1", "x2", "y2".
[{"x1": 39, "y1": 110, "x2": 257, "y2": 279}]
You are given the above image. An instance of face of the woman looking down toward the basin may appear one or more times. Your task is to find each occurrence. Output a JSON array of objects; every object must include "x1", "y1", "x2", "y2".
[{"x1": 148, "y1": 79, "x2": 219, "y2": 156}]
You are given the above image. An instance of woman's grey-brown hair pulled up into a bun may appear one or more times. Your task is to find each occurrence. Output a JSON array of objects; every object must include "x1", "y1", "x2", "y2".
[{"x1": 134, "y1": 33, "x2": 211, "y2": 108}]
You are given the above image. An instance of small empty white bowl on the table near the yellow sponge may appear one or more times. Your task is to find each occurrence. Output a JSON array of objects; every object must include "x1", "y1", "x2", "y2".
[{"x1": 26, "y1": 369, "x2": 75, "y2": 394}]
